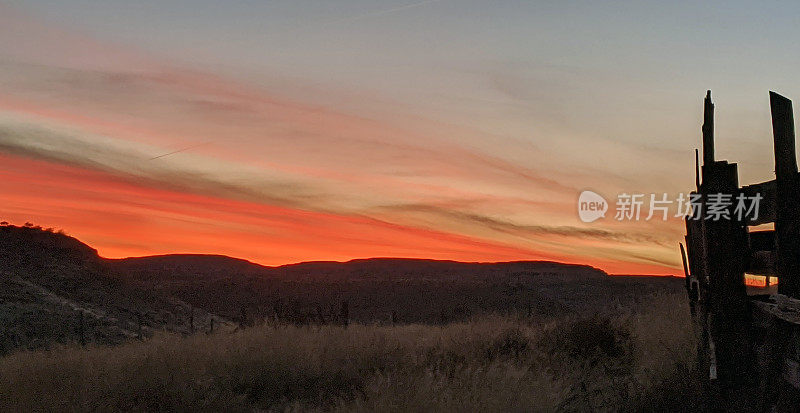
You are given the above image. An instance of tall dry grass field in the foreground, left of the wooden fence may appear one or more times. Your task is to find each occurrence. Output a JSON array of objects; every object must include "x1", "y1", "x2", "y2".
[{"x1": 0, "y1": 295, "x2": 694, "y2": 411}]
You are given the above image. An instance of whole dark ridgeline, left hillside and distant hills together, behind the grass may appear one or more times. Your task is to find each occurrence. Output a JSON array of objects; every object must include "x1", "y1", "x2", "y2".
[{"x1": 0, "y1": 224, "x2": 681, "y2": 354}]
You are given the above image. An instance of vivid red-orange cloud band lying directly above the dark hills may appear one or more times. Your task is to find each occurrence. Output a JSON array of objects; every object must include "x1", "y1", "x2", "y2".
[{"x1": 0, "y1": 151, "x2": 676, "y2": 273}]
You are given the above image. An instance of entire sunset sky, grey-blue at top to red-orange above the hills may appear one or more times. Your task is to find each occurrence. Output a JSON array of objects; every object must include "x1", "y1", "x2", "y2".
[{"x1": 0, "y1": 0, "x2": 800, "y2": 274}]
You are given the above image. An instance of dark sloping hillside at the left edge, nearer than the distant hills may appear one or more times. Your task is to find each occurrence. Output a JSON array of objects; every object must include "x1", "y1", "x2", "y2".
[{"x1": 0, "y1": 226, "x2": 222, "y2": 354}]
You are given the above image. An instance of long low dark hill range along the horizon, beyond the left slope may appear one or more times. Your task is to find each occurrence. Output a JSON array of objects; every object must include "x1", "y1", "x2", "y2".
[{"x1": 109, "y1": 255, "x2": 681, "y2": 323}]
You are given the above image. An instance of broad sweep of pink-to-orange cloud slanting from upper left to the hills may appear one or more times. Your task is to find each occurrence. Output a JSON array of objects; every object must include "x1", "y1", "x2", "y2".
[{"x1": 0, "y1": 6, "x2": 680, "y2": 274}]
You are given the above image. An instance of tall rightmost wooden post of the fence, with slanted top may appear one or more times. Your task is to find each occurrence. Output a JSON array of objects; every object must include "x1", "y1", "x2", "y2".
[{"x1": 769, "y1": 92, "x2": 800, "y2": 298}]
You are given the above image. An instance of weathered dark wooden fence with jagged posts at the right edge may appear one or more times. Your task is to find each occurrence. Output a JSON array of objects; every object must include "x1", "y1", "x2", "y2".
[{"x1": 681, "y1": 91, "x2": 800, "y2": 412}]
